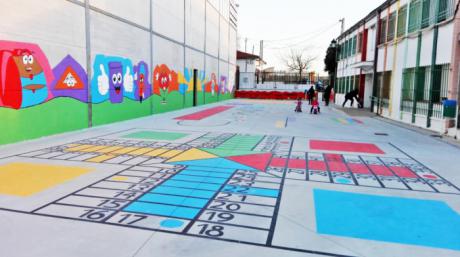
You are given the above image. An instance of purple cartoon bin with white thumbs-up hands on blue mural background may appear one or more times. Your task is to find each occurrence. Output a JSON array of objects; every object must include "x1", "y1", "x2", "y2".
[{"x1": 91, "y1": 55, "x2": 136, "y2": 104}]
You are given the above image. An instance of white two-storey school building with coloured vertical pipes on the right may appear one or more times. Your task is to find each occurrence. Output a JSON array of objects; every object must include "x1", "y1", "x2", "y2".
[{"x1": 336, "y1": 0, "x2": 460, "y2": 136}]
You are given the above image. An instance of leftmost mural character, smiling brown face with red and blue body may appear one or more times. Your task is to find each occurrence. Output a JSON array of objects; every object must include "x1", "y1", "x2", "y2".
[{"x1": 0, "y1": 40, "x2": 54, "y2": 109}]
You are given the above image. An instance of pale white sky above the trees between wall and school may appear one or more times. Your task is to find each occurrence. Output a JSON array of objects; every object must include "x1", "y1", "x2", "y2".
[{"x1": 237, "y1": 0, "x2": 383, "y2": 73}]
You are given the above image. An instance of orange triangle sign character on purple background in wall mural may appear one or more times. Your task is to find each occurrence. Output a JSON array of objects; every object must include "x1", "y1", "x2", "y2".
[{"x1": 50, "y1": 55, "x2": 88, "y2": 103}]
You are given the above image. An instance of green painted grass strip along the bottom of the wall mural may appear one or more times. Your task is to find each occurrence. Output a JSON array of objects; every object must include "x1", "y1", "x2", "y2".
[{"x1": 0, "y1": 91, "x2": 233, "y2": 145}]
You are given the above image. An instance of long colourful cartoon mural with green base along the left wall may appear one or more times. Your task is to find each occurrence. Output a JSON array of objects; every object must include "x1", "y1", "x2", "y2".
[{"x1": 0, "y1": 40, "x2": 232, "y2": 144}]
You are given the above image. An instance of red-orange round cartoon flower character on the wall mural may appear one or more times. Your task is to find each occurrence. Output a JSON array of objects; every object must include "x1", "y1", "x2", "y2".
[{"x1": 153, "y1": 64, "x2": 179, "y2": 104}]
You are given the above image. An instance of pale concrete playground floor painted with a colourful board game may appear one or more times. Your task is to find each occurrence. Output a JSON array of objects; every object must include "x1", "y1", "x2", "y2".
[{"x1": 0, "y1": 100, "x2": 460, "y2": 257}]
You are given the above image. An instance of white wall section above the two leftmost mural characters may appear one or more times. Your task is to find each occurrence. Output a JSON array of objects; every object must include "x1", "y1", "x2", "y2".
[{"x1": 0, "y1": 0, "x2": 86, "y2": 67}]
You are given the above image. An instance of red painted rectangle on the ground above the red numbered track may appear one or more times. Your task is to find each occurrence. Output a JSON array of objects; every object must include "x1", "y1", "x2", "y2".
[{"x1": 310, "y1": 140, "x2": 385, "y2": 154}]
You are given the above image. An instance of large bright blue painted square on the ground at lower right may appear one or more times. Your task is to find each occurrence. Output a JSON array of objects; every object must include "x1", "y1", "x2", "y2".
[{"x1": 314, "y1": 190, "x2": 460, "y2": 251}]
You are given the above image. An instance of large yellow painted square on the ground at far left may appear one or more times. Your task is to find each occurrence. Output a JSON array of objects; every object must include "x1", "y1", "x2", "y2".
[{"x1": 0, "y1": 163, "x2": 91, "y2": 196}]
